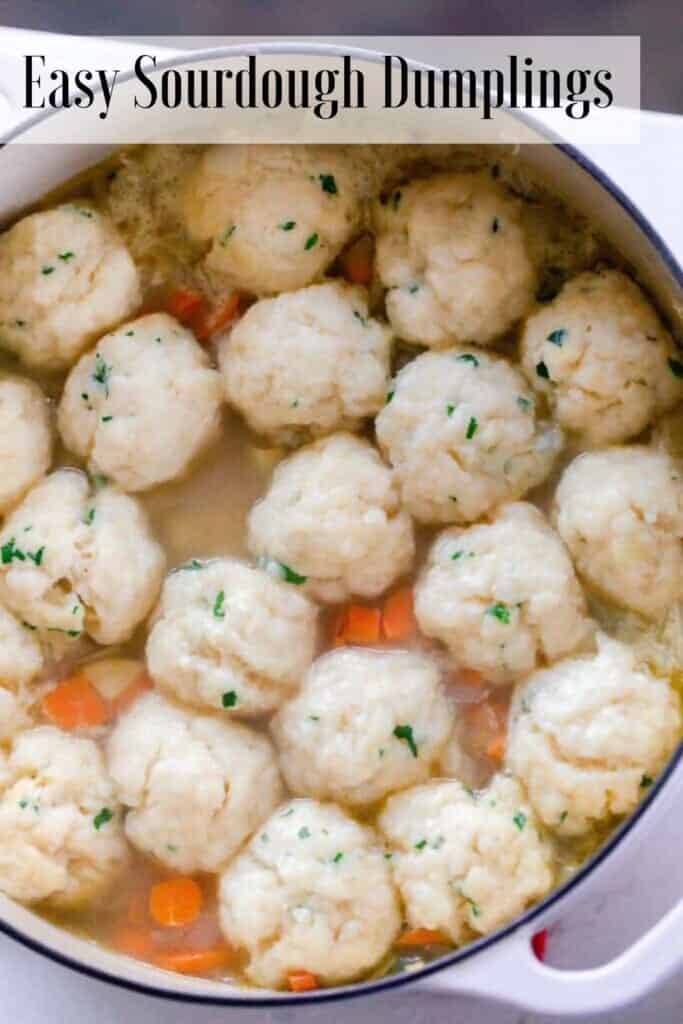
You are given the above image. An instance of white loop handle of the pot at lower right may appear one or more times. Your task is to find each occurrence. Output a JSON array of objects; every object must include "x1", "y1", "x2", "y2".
[{"x1": 421, "y1": 900, "x2": 683, "y2": 1016}]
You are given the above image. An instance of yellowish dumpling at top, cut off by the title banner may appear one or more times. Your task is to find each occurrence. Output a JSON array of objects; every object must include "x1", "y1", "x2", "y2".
[{"x1": 183, "y1": 145, "x2": 359, "y2": 295}]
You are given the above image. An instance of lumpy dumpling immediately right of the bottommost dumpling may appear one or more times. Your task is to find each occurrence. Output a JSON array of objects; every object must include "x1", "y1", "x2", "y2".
[{"x1": 378, "y1": 775, "x2": 554, "y2": 944}]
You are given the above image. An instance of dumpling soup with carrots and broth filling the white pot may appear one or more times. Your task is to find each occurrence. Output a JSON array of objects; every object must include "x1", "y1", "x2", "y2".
[{"x1": 0, "y1": 145, "x2": 683, "y2": 992}]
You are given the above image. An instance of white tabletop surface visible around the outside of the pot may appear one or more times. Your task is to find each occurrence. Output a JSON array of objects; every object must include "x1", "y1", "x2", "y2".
[{"x1": 0, "y1": 30, "x2": 683, "y2": 1024}]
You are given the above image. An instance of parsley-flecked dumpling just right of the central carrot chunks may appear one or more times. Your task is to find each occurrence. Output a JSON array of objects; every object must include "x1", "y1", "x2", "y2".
[{"x1": 415, "y1": 502, "x2": 593, "y2": 684}]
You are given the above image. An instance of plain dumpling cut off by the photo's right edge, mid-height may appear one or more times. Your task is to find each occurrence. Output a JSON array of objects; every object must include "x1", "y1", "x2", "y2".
[{"x1": 554, "y1": 445, "x2": 683, "y2": 617}]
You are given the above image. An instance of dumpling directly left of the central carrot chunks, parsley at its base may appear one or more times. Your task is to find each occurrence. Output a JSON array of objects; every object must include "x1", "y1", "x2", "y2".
[{"x1": 146, "y1": 558, "x2": 317, "y2": 716}]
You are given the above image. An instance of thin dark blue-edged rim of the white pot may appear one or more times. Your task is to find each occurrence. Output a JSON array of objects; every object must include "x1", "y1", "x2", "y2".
[{"x1": 0, "y1": 37, "x2": 683, "y2": 1008}]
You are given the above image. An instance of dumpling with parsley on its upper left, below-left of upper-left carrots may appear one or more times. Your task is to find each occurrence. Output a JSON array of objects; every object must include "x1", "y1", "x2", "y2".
[{"x1": 57, "y1": 313, "x2": 222, "y2": 490}]
